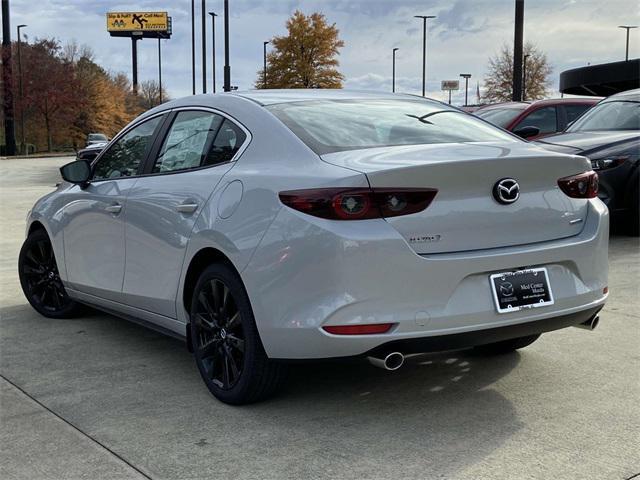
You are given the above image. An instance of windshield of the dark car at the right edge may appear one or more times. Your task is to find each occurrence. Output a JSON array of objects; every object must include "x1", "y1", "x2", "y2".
[{"x1": 567, "y1": 100, "x2": 640, "y2": 132}]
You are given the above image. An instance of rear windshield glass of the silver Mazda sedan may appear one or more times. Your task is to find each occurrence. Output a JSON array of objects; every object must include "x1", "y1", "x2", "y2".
[{"x1": 267, "y1": 99, "x2": 519, "y2": 155}]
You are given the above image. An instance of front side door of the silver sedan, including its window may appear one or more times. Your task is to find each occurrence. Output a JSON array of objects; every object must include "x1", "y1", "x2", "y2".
[{"x1": 61, "y1": 115, "x2": 163, "y2": 301}]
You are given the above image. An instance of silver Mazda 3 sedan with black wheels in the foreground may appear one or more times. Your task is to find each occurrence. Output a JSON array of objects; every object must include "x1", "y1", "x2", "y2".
[{"x1": 19, "y1": 90, "x2": 608, "y2": 404}]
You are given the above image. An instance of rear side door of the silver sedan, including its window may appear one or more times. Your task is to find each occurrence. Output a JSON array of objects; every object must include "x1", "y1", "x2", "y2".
[{"x1": 123, "y1": 109, "x2": 248, "y2": 318}]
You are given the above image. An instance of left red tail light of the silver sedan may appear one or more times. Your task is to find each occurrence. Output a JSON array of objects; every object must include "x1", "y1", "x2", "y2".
[{"x1": 279, "y1": 188, "x2": 438, "y2": 220}]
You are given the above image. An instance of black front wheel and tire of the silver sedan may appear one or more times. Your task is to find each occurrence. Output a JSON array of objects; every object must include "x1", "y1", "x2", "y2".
[{"x1": 18, "y1": 229, "x2": 81, "y2": 318}]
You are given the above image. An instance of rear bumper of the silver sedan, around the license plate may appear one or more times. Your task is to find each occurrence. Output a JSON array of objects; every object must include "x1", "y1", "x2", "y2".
[{"x1": 241, "y1": 199, "x2": 608, "y2": 359}]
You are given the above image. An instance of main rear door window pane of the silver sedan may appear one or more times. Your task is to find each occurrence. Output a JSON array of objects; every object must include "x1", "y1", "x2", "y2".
[{"x1": 152, "y1": 110, "x2": 224, "y2": 173}]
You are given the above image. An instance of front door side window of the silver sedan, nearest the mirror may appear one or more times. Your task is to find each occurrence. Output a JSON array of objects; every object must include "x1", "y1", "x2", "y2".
[{"x1": 92, "y1": 115, "x2": 164, "y2": 180}]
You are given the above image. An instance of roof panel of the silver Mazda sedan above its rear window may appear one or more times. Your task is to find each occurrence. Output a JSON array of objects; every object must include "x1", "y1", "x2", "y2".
[{"x1": 235, "y1": 88, "x2": 419, "y2": 105}]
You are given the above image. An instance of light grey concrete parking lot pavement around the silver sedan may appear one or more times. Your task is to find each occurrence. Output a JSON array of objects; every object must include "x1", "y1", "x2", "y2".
[{"x1": 0, "y1": 158, "x2": 640, "y2": 480}]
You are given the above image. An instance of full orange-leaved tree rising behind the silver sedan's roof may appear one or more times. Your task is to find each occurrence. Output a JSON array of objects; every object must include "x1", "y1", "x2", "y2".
[{"x1": 255, "y1": 10, "x2": 344, "y2": 88}]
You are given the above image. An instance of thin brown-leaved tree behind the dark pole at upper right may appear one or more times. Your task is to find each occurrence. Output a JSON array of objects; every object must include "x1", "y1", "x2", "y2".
[{"x1": 483, "y1": 42, "x2": 553, "y2": 103}]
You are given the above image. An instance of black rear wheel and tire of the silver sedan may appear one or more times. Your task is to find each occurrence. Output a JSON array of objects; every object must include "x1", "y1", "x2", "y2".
[{"x1": 189, "y1": 264, "x2": 286, "y2": 405}]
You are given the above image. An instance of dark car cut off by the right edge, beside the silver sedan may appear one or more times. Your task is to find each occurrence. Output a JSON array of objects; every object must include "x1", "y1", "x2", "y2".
[{"x1": 538, "y1": 89, "x2": 640, "y2": 235}]
